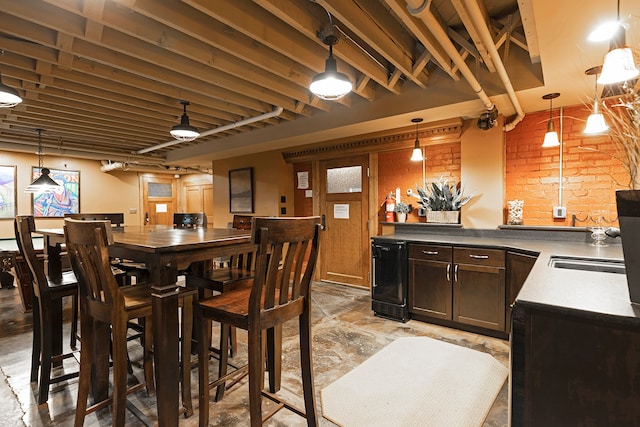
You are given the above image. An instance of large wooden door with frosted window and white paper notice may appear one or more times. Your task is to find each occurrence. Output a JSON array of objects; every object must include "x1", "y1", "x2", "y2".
[{"x1": 319, "y1": 156, "x2": 370, "y2": 288}]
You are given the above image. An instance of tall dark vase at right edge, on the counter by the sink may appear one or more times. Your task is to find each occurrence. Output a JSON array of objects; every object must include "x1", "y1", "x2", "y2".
[{"x1": 616, "y1": 190, "x2": 640, "y2": 304}]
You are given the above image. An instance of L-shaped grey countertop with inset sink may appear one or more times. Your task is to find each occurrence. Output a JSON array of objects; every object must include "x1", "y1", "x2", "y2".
[{"x1": 374, "y1": 227, "x2": 640, "y2": 321}]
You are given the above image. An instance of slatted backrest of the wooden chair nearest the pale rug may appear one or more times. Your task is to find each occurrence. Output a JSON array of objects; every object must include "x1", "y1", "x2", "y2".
[{"x1": 249, "y1": 216, "x2": 320, "y2": 322}]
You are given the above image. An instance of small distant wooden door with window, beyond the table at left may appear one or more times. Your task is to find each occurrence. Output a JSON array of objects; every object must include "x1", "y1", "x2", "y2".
[{"x1": 140, "y1": 175, "x2": 177, "y2": 225}]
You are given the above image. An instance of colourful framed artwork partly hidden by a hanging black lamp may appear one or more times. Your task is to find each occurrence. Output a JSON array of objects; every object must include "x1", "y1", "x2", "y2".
[{"x1": 32, "y1": 167, "x2": 80, "y2": 217}]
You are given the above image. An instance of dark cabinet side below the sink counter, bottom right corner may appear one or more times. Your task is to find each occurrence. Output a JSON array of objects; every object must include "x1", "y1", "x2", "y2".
[{"x1": 510, "y1": 303, "x2": 640, "y2": 427}]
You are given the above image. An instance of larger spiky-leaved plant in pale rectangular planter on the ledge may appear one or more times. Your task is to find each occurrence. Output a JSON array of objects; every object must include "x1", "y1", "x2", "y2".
[{"x1": 414, "y1": 177, "x2": 474, "y2": 223}]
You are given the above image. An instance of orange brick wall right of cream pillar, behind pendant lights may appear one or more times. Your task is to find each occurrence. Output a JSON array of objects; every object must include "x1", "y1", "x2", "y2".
[{"x1": 505, "y1": 105, "x2": 629, "y2": 226}]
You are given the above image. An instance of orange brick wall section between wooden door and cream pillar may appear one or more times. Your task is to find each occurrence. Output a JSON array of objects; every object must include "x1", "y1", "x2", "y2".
[{"x1": 378, "y1": 142, "x2": 460, "y2": 222}]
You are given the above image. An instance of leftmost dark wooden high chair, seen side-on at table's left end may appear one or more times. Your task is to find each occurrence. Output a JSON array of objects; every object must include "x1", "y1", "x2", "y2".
[{"x1": 14, "y1": 215, "x2": 78, "y2": 405}]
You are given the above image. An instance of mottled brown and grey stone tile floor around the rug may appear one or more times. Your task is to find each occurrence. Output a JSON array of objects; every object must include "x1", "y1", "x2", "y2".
[{"x1": 0, "y1": 283, "x2": 509, "y2": 427}]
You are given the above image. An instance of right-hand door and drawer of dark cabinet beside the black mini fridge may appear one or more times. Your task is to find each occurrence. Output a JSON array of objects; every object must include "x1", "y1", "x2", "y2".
[{"x1": 453, "y1": 248, "x2": 505, "y2": 331}]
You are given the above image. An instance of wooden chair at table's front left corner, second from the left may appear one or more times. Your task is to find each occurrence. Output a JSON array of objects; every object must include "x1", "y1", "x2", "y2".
[{"x1": 65, "y1": 219, "x2": 195, "y2": 426}]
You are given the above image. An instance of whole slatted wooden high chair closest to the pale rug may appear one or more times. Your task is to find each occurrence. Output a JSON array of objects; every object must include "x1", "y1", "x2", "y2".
[{"x1": 194, "y1": 217, "x2": 320, "y2": 426}]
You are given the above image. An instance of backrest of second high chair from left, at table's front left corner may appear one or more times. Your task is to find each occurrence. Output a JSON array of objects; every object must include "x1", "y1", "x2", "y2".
[{"x1": 64, "y1": 218, "x2": 124, "y2": 321}]
